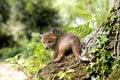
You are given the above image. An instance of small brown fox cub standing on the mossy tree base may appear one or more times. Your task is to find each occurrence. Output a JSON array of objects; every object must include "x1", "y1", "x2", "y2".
[{"x1": 40, "y1": 29, "x2": 88, "y2": 62}]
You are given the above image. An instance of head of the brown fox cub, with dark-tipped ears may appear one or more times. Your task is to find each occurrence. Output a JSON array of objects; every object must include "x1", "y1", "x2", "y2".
[{"x1": 40, "y1": 29, "x2": 57, "y2": 49}]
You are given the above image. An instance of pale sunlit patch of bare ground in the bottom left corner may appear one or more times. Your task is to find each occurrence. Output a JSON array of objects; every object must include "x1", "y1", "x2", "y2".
[{"x1": 0, "y1": 62, "x2": 26, "y2": 80}]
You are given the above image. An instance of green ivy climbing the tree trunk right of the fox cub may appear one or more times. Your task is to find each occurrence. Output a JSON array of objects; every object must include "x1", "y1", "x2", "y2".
[{"x1": 86, "y1": 30, "x2": 119, "y2": 80}]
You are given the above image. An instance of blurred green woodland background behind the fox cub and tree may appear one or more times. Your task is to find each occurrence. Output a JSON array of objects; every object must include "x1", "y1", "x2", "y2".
[{"x1": 0, "y1": 0, "x2": 109, "y2": 61}]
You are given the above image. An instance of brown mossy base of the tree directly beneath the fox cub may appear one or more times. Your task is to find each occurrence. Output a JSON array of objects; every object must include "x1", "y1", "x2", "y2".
[{"x1": 38, "y1": 54, "x2": 88, "y2": 80}]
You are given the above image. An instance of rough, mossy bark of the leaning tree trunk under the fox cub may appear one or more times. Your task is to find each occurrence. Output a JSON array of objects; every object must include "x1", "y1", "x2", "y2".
[{"x1": 38, "y1": 0, "x2": 120, "y2": 80}]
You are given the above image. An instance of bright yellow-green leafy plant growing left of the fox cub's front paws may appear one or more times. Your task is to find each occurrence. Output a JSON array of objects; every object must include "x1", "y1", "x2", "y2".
[{"x1": 6, "y1": 44, "x2": 52, "y2": 80}]
